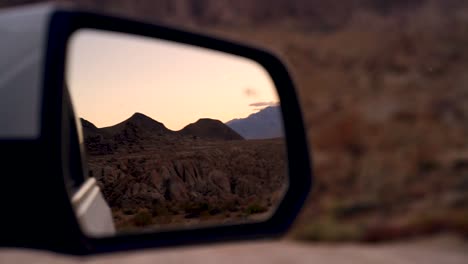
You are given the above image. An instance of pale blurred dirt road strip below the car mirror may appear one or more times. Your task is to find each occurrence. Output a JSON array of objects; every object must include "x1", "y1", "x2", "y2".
[{"x1": 0, "y1": 235, "x2": 468, "y2": 264}]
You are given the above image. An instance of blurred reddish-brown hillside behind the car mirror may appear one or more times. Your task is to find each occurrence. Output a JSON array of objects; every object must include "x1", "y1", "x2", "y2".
[{"x1": 0, "y1": 0, "x2": 468, "y2": 241}]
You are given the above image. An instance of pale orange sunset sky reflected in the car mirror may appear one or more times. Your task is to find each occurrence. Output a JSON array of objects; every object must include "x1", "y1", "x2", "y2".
[{"x1": 66, "y1": 30, "x2": 279, "y2": 130}]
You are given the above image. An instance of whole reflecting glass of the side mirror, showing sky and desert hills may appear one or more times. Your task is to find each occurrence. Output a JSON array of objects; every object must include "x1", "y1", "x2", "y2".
[{"x1": 66, "y1": 29, "x2": 288, "y2": 236}]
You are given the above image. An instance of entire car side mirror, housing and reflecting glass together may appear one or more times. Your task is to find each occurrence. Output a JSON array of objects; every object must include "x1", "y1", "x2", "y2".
[{"x1": 0, "y1": 5, "x2": 312, "y2": 254}]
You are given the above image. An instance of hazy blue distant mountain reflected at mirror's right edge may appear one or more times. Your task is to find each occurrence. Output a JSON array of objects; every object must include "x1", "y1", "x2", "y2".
[{"x1": 226, "y1": 106, "x2": 283, "y2": 139}]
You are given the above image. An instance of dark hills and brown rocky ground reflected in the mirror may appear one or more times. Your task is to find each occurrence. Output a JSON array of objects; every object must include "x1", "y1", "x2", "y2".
[{"x1": 82, "y1": 113, "x2": 287, "y2": 231}]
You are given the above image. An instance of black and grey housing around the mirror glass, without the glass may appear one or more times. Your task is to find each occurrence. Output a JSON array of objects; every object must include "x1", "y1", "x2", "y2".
[{"x1": 0, "y1": 5, "x2": 312, "y2": 255}]
